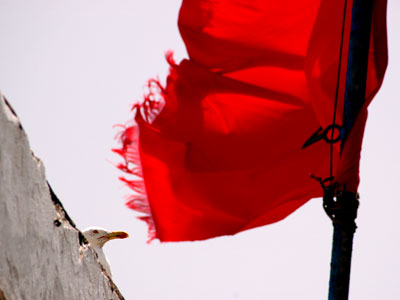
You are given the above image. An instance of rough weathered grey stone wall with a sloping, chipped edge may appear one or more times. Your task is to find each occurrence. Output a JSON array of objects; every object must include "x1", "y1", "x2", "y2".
[{"x1": 0, "y1": 94, "x2": 123, "y2": 300}]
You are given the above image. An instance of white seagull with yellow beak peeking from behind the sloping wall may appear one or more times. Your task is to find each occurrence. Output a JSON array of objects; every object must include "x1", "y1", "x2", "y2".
[{"x1": 82, "y1": 227, "x2": 129, "y2": 277}]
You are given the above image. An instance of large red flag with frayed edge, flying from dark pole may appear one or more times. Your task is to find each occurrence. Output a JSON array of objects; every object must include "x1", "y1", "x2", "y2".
[{"x1": 116, "y1": 0, "x2": 387, "y2": 241}]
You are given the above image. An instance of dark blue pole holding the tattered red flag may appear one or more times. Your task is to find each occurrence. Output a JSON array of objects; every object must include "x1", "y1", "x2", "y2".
[{"x1": 324, "y1": 0, "x2": 374, "y2": 300}]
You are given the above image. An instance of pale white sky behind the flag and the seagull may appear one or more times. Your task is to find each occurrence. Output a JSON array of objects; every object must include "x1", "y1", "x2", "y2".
[{"x1": 0, "y1": 0, "x2": 400, "y2": 300}]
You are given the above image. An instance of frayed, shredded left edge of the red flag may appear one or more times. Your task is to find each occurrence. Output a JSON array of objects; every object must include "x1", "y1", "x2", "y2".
[{"x1": 112, "y1": 51, "x2": 176, "y2": 243}]
